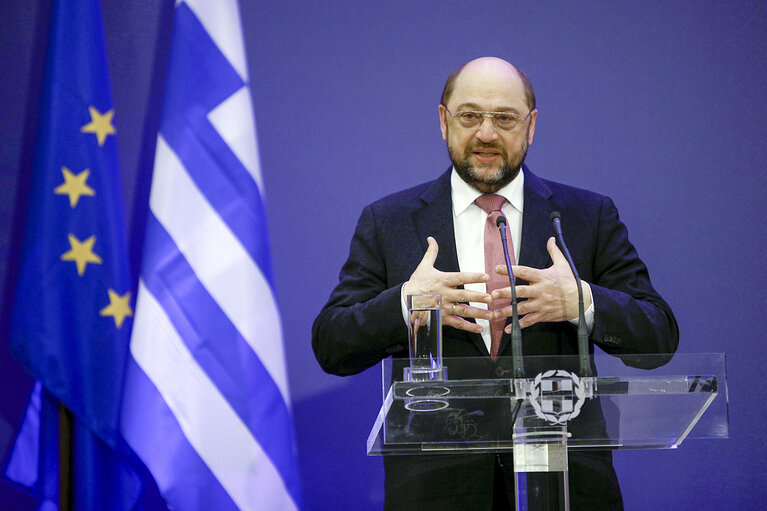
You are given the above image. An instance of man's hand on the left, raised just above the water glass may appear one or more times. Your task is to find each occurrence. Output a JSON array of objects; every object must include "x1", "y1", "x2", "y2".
[{"x1": 403, "y1": 236, "x2": 491, "y2": 333}]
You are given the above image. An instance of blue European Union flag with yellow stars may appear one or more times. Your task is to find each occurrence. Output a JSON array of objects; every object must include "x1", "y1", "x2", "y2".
[{"x1": 11, "y1": 0, "x2": 141, "y2": 509}]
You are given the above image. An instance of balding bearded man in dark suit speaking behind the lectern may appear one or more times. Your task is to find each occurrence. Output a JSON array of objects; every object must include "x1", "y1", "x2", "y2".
[{"x1": 312, "y1": 58, "x2": 679, "y2": 510}]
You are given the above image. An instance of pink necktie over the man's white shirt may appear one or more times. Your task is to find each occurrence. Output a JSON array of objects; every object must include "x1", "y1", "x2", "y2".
[{"x1": 475, "y1": 193, "x2": 516, "y2": 360}]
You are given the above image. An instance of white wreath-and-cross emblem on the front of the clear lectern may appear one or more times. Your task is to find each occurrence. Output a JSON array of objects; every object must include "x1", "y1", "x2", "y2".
[{"x1": 530, "y1": 369, "x2": 585, "y2": 424}]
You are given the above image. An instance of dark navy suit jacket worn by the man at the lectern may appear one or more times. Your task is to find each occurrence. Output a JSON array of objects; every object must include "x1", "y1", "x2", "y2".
[{"x1": 312, "y1": 167, "x2": 679, "y2": 509}]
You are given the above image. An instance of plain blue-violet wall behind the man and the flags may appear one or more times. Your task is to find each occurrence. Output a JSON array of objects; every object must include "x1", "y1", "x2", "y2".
[{"x1": 0, "y1": 0, "x2": 767, "y2": 510}]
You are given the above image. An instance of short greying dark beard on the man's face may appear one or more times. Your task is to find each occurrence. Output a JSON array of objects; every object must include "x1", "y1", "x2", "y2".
[{"x1": 447, "y1": 128, "x2": 527, "y2": 193}]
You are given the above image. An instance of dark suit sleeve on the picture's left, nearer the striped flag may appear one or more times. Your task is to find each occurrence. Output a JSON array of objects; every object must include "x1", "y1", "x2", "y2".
[{"x1": 312, "y1": 207, "x2": 407, "y2": 376}]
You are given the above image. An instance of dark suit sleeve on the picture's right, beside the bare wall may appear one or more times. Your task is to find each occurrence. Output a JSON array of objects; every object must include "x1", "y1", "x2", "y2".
[{"x1": 591, "y1": 198, "x2": 679, "y2": 365}]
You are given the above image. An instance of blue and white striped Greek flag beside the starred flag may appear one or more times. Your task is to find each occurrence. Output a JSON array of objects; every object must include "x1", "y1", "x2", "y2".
[{"x1": 122, "y1": 0, "x2": 301, "y2": 510}]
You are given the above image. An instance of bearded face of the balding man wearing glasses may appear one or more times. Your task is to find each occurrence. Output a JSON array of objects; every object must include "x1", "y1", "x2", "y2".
[{"x1": 439, "y1": 59, "x2": 537, "y2": 193}]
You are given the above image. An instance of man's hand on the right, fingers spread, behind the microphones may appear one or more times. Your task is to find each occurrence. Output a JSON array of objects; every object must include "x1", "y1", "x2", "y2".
[{"x1": 492, "y1": 237, "x2": 591, "y2": 333}]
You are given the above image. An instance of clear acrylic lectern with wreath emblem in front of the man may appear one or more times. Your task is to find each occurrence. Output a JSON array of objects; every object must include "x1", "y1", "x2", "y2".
[{"x1": 367, "y1": 353, "x2": 729, "y2": 510}]
